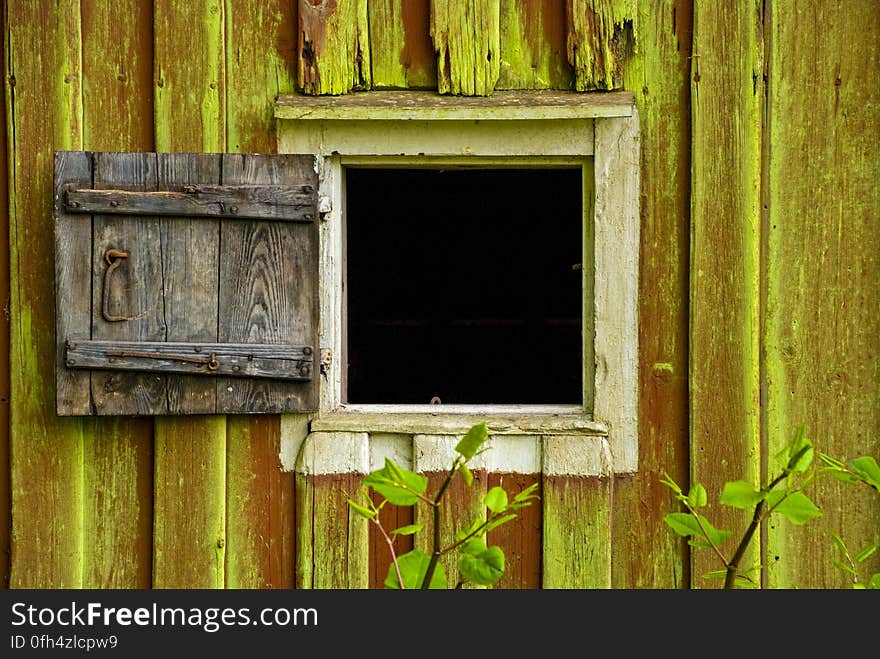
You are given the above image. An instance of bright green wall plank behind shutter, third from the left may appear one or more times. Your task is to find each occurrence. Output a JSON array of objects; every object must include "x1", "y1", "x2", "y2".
[{"x1": 153, "y1": 0, "x2": 227, "y2": 588}]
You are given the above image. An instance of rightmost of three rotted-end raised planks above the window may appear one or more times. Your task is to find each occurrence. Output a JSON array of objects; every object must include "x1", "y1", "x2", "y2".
[{"x1": 566, "y1": 0, "x2": 636, "y2": 91}]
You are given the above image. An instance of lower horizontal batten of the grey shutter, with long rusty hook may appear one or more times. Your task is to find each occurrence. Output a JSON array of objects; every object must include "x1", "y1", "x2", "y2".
[{"x1": 65, "y1": 341, "x2": 314, "y2": 381}]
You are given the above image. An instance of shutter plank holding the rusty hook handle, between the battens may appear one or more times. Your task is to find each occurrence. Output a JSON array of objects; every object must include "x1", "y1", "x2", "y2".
[{"x1": 92, "y1": 153, "x2": 166, "y2": 415}]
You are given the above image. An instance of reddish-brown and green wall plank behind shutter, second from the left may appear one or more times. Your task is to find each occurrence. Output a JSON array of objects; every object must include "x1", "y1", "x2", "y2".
[{"x1": 80, "y1": 0, "x2": 153, "y2": 588}]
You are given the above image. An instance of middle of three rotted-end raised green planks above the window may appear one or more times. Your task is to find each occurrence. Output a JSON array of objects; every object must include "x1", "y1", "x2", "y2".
[{"x1": 430, "y1": 0, "x2": 501, "y2": 96}]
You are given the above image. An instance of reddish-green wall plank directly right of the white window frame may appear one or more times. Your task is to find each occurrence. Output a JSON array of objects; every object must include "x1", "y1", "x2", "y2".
[{"x1": 612, "y1": 0, "x2": 691, "y2": 588}]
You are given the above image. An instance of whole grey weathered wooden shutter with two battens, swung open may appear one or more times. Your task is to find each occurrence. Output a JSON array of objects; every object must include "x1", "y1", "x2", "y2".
[{"x1": 55, "y1": 151, "x2": 319, "y2": 416}]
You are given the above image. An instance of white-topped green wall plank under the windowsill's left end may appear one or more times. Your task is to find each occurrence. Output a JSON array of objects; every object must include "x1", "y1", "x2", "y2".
[{"x1": 296, "y1": 433, "x2": 370, "y2": 589}]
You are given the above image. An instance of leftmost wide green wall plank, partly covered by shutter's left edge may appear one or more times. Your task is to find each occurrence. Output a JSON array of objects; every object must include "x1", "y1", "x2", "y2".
[{"x1": 3, "y1": 0, "x2": 83, "y2": 588}]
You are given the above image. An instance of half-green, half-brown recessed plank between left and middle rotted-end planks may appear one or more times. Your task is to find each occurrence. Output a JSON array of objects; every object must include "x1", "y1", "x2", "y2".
[{"x1": 368, "y1": 0, "x2": 437, "y2": 89}]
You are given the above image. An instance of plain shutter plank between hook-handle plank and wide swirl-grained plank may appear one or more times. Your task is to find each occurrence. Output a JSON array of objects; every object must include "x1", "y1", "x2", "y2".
[{"x1": 158, "y1": 153, "x2": 220, "y2": 414}]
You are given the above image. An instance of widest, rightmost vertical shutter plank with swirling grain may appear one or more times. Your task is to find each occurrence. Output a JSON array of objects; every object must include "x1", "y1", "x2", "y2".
[{"x1": 217, "y1": 154, "x2": 319, "y2": 412}]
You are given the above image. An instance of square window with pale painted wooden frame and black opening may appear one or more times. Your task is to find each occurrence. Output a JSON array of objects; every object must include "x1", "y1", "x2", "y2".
[{"x1": 276, "y1": 91, "x2": 639, "y2": 472}]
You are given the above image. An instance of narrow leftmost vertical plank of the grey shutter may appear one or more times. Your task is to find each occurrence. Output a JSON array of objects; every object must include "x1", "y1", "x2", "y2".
[{"x1": 55, "y1": 151, "x2": 93, "y2": 415}]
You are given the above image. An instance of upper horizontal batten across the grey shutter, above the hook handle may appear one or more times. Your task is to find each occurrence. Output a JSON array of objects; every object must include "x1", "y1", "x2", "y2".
[{"x1": 65, "y1": 185, "x2": 317, "y2": 222}]
